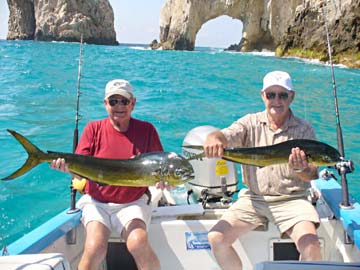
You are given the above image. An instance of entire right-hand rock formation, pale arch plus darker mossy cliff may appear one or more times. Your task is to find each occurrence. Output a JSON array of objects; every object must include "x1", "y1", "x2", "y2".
[{"x1": 154, "y1": 0, "x2": 360, "y2": 67}]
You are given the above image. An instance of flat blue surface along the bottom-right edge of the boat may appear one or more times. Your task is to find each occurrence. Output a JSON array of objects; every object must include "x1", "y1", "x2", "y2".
[{"x1": 254, "y1": 261, "x2": 360, "y2": 270}]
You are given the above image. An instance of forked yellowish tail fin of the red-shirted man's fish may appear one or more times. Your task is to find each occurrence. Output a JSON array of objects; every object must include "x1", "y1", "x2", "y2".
[{"x1": 1, "y1": 129, "x2": 45, "y2": 180}]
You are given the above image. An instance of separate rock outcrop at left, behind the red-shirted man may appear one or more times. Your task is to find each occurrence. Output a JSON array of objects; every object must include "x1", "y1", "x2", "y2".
[{"x1": 7, "y1": 0, "x2": 118, "y2": 45}]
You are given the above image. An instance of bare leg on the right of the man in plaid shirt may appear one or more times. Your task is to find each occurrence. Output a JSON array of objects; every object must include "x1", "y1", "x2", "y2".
[{"x1": 286, "y1": 221, "x2": 321, "y2": 261}]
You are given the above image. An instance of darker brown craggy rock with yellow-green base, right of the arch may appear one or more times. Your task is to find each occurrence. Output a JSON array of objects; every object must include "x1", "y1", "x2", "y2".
[{"x1": 277, "y1": 0, "x2": 360, "y2": 68}]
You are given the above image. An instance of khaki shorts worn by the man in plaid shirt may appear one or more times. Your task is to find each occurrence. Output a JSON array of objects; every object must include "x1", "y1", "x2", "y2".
[{"x1": 221, "y1": 189, "x2": 320, "y2": 234}]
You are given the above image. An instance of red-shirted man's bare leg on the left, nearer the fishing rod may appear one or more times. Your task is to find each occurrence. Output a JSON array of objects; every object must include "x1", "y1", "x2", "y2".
[{"x1": 78, "y1": 221, "x2": 110, "y2": 270}]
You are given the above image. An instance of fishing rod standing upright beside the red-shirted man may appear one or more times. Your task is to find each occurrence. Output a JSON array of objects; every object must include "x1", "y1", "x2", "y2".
[{"x1": 67, "y1": 35, "x2": 83, "y2": 214}]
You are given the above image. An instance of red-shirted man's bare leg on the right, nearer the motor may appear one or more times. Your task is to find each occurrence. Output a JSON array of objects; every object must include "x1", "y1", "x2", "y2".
[{"x1": 122, "y1": 219, "x2": 160, "y2": 270}]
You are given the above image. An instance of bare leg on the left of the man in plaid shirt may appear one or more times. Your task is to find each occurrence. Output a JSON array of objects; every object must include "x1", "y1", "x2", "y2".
[{"x1": 208, "y1": 220, "x2": 257, "y2": 270}]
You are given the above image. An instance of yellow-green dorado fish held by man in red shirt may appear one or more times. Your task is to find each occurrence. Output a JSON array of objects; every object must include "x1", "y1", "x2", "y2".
[{"x1": 2, "y1": 130, "x2": 194, "y2": 187}]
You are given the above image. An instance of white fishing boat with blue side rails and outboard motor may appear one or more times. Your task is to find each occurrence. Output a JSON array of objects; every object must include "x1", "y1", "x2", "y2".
[{"x1": 0, "y1": 127, "x2": 360, "y2": 270}]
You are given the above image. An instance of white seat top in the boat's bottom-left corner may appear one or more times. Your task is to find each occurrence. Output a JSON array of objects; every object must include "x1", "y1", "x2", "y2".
[{"x1": 0, "y1": 253, "x2": 71, "y2": 270}]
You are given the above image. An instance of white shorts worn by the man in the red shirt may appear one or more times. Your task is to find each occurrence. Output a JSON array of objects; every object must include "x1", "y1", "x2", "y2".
[{"x1": 77, "y1": 194, "x2": 152, "y2": 235}]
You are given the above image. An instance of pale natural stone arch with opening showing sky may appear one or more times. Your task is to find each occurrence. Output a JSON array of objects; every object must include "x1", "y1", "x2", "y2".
[{"x1": 160, "y1": 0, "x2": 302, "y2": 51}]
